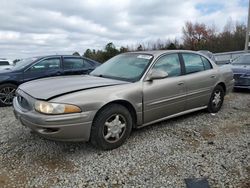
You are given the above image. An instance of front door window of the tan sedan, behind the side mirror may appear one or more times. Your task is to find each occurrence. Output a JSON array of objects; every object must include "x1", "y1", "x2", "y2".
[{"x1": 153, "y1": 54, "x2": 181, "y2": 77}]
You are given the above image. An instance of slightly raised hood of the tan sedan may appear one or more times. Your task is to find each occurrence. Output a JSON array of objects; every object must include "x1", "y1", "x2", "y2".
[{"x1": 19, "y1": 75, "x2": 129, "y2": 100}]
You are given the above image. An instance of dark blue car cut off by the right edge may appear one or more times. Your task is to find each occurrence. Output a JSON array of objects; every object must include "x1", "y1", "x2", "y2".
[{"x1": 232, "y1": 53, "x2": 250, "y2": 89}]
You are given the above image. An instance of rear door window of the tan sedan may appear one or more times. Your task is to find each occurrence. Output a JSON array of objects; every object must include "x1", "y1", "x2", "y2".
[{"x1": 182, "y1": 53, "x2": 204, "y2": 74}]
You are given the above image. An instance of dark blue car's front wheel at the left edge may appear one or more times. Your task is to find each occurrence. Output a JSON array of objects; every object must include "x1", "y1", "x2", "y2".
[{"x1": 0, "y1": 84, "x2": 17, "y2": 107}]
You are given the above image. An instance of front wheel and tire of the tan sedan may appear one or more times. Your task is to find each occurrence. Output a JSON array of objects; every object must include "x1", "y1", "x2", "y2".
[{"x1": 90, "y1": 104, "x2": 133, "y2": 150}]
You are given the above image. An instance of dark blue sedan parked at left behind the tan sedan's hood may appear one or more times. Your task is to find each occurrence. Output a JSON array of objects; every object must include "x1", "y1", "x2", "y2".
[{"x1": 0, "y1": 55, "x2": 100, "y2": 106}]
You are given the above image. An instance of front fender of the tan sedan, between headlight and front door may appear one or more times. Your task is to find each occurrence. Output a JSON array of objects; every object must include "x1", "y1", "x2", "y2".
[{"x1": 50, "y1": 82, "x2": 143, "y2": 124}]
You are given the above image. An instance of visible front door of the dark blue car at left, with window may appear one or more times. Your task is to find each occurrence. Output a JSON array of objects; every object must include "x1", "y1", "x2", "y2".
[{"x1": 23, "y1": 57, "x2": 62, "y2": 82}]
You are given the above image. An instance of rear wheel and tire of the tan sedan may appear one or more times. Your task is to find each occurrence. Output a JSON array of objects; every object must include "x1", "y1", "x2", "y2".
[{"x1": 207, "y1": 85, "x2": 225, "y2": 113}]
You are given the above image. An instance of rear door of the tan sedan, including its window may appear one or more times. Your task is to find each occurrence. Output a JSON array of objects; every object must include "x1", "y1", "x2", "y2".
[{"x1": 182, "y1": 53, "x2": 217, "y2": 110}]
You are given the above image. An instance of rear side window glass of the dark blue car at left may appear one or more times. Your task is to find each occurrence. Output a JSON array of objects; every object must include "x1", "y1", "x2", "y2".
[{"x1": 63, "y1": 57, "x2": 91, "y2": 70}]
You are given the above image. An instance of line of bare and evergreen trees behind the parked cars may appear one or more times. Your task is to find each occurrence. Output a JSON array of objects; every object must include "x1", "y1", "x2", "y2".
[{"x1": 73, "y1": 20, "x2": 246, "y2": 62}]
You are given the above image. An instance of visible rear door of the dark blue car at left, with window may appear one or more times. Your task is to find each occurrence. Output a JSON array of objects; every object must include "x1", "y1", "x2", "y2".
[{"x1": 63, "y1": 57, "x2": 92, "y2": 75}]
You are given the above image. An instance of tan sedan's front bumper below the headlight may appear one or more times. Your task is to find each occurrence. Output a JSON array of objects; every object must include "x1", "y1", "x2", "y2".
[{"x1": 13, "y1": 97, "x2": 94, "y2": 141}]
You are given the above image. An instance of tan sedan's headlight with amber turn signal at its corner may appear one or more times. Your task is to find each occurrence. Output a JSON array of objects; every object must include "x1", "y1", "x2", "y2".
[{"x1": 35, "y1": 101, "x2": 81, "y2": 114}]
